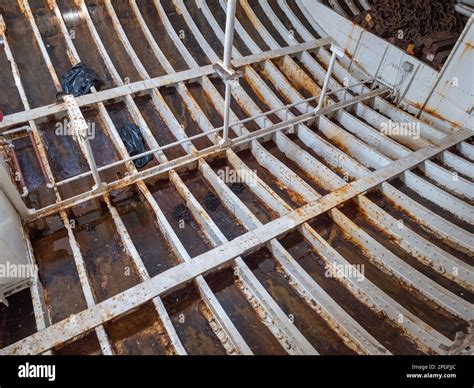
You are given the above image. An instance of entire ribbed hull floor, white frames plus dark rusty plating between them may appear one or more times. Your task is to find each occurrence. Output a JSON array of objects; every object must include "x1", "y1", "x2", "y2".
[{"x1": 0, "y1": 0, "x2": 474, "y2": 354}]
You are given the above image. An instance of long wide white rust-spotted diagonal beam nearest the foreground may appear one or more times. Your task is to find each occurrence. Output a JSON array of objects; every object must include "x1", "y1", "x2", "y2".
[{"x1": 0, "y1": 131, "x2": 470, "y2": 354}]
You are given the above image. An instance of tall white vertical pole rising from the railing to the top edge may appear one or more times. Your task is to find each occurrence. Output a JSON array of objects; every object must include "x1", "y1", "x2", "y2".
[{"x1": 221, "y1": 0, "x2": 237, "y2": 146}]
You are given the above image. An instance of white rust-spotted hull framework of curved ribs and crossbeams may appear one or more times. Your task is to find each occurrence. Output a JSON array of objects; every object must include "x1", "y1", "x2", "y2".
[{"x1": 0, "y1": 0, "x2": 474, "y2": 354}]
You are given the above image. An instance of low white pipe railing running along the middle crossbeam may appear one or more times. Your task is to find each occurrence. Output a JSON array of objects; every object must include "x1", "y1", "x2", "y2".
[{"x1": 0, "y1": 57, "x2": 393, "y2": 219}]
